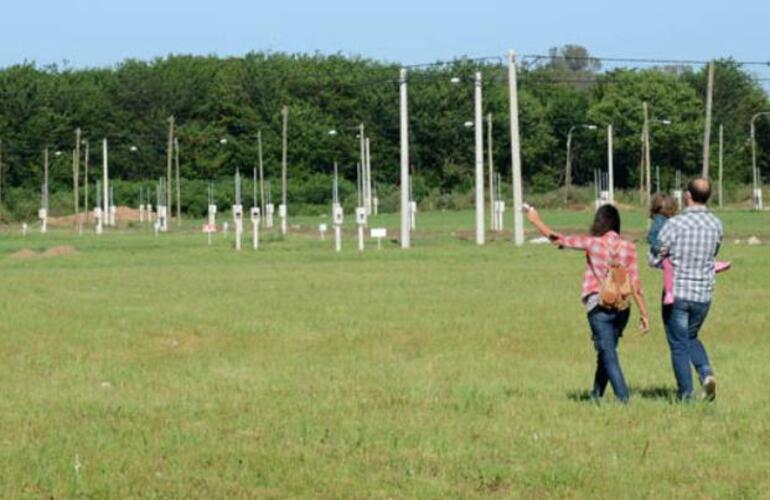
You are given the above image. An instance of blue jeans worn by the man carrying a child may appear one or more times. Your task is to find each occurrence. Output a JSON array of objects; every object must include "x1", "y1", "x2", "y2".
[{"x1": 663, "y1": 299, "x2": 714, "y2": 400}]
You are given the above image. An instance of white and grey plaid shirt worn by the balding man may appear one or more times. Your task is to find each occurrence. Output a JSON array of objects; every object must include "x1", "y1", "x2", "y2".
[{"x1": 647, "y1": 205, "x2": 722, "y2": 302}]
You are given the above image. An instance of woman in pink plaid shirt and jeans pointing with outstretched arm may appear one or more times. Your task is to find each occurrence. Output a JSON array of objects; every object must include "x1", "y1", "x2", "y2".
[{"x1": 525, "y1": 205, "x2": 649, "y2": 403}]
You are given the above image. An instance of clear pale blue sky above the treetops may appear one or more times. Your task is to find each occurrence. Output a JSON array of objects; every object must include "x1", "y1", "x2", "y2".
[{"x1": 0, "y1": 0, "x2": 770, "y2": 67}]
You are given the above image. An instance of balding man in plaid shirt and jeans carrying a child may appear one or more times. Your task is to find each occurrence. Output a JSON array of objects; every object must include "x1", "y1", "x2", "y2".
[{"x1": 648, "y1": 178, "x2": 722, "y2": 401}]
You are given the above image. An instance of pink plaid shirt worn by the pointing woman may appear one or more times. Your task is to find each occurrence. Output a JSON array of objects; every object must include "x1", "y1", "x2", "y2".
[{"x1": 556, "y1": 231, "x2": 642, "y2": 300}]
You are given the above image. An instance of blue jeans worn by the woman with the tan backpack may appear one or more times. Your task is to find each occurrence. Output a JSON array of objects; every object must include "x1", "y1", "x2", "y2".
[{"x1": 588, "y1": 306, "x2": 629, "y2": 403}]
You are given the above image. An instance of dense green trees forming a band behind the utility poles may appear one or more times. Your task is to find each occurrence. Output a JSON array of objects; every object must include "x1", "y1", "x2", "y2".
[{"x1": 0, "y1": 46, "x2": 770, "y2": 219}]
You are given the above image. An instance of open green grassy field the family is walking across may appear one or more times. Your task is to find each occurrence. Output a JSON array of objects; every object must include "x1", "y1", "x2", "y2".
[{"x1": 0, "y1": 206, "x2": 770, "y2": 498}]
